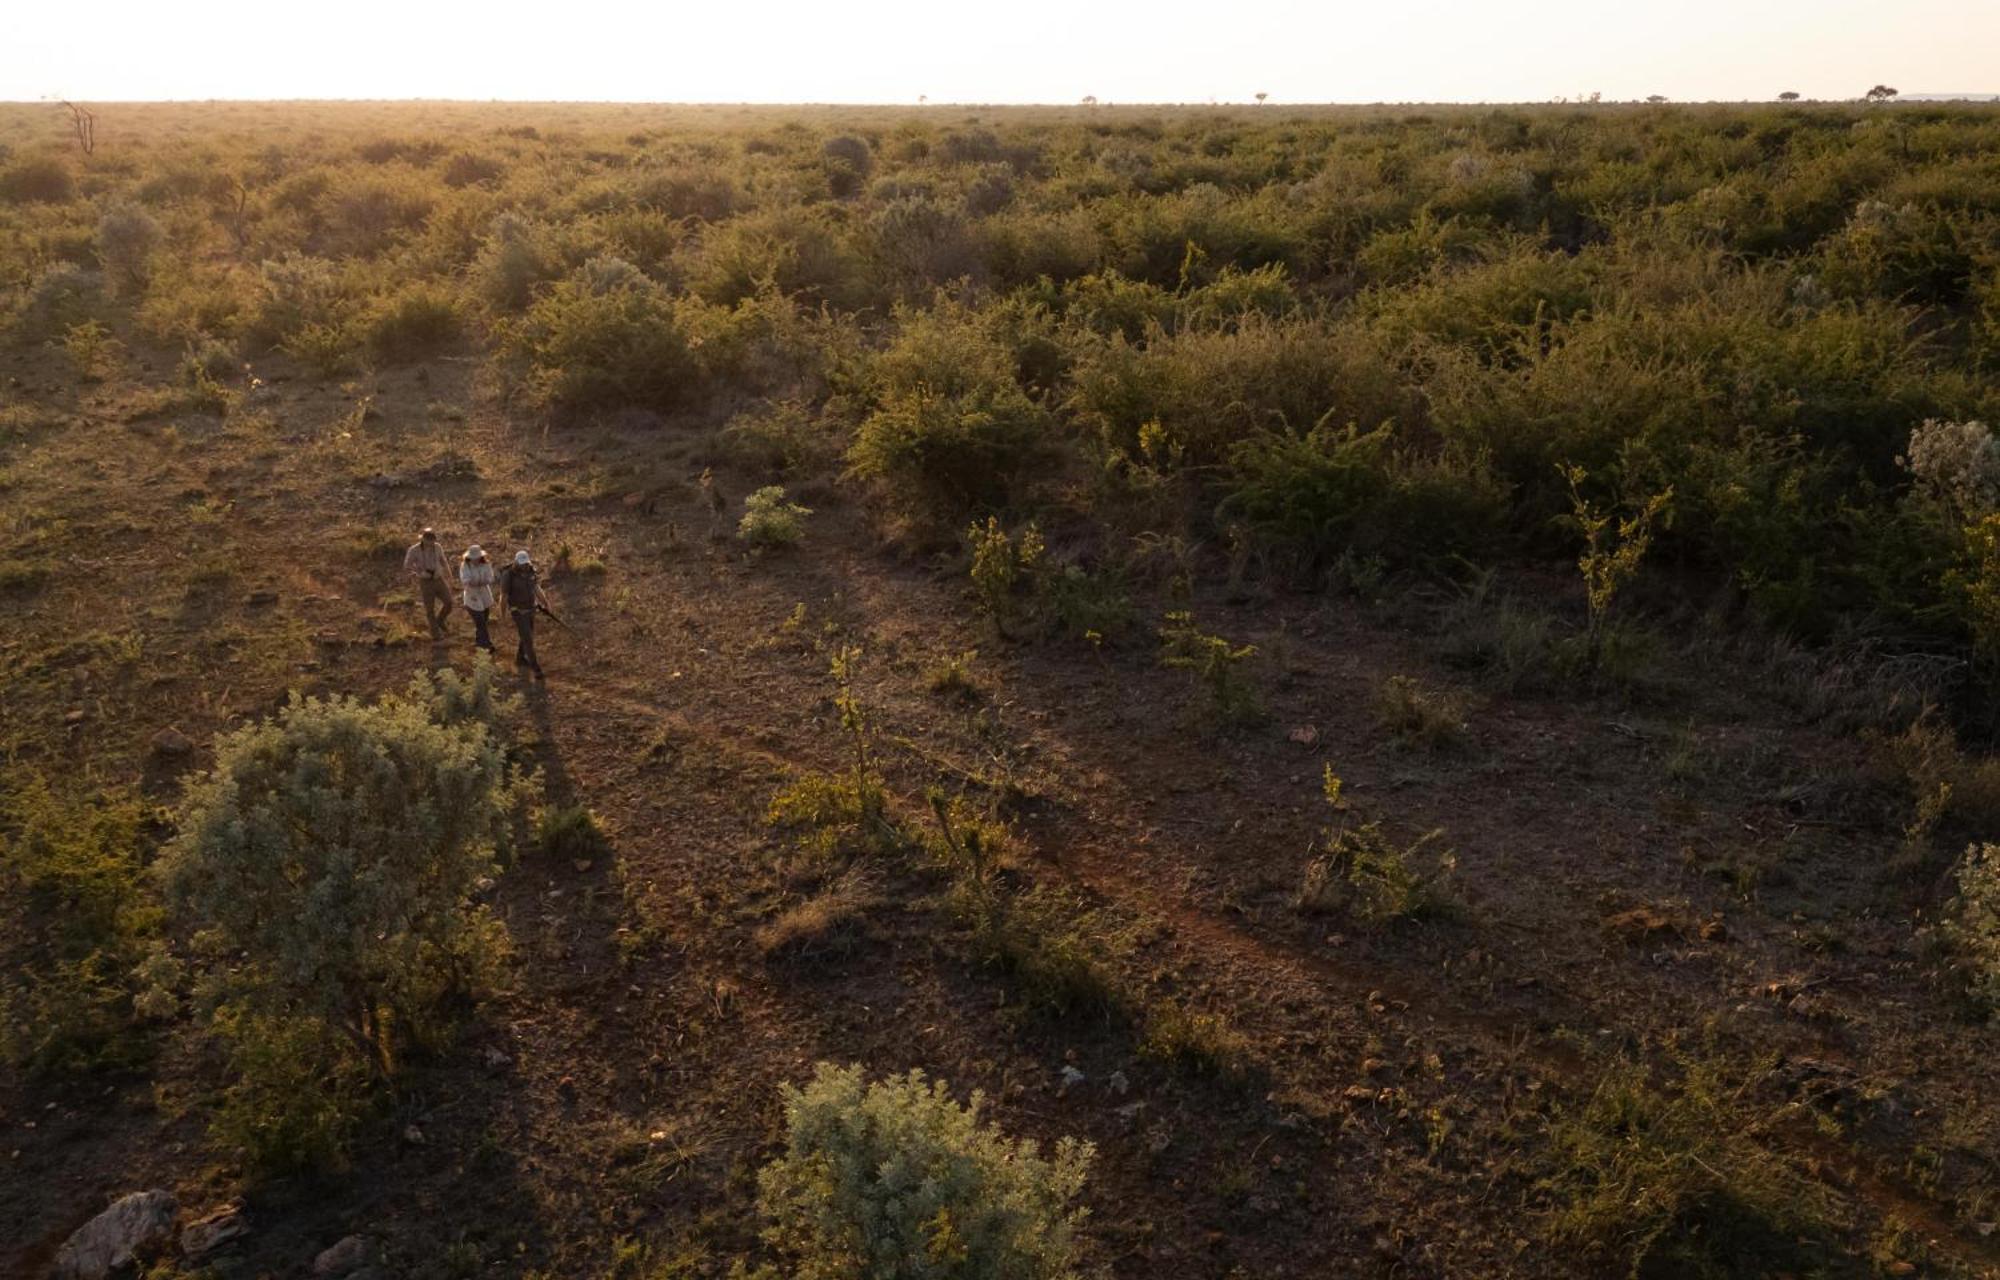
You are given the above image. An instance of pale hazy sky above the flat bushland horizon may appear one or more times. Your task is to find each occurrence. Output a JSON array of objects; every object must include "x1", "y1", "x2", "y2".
[{"x1": 0, "y1": 0, "x2": 2000, "y2": 102}]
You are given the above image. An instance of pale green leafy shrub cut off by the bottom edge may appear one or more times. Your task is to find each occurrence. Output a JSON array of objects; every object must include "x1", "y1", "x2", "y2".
[{"x1": 758, "y1": 1062, "x2": 1094, "y2": 1280}]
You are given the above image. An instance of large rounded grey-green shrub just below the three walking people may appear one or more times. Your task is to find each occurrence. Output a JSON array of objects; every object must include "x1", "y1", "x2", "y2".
[{"x1": 162, "y1": 662, "x2": 520, "y2": 1104}]
